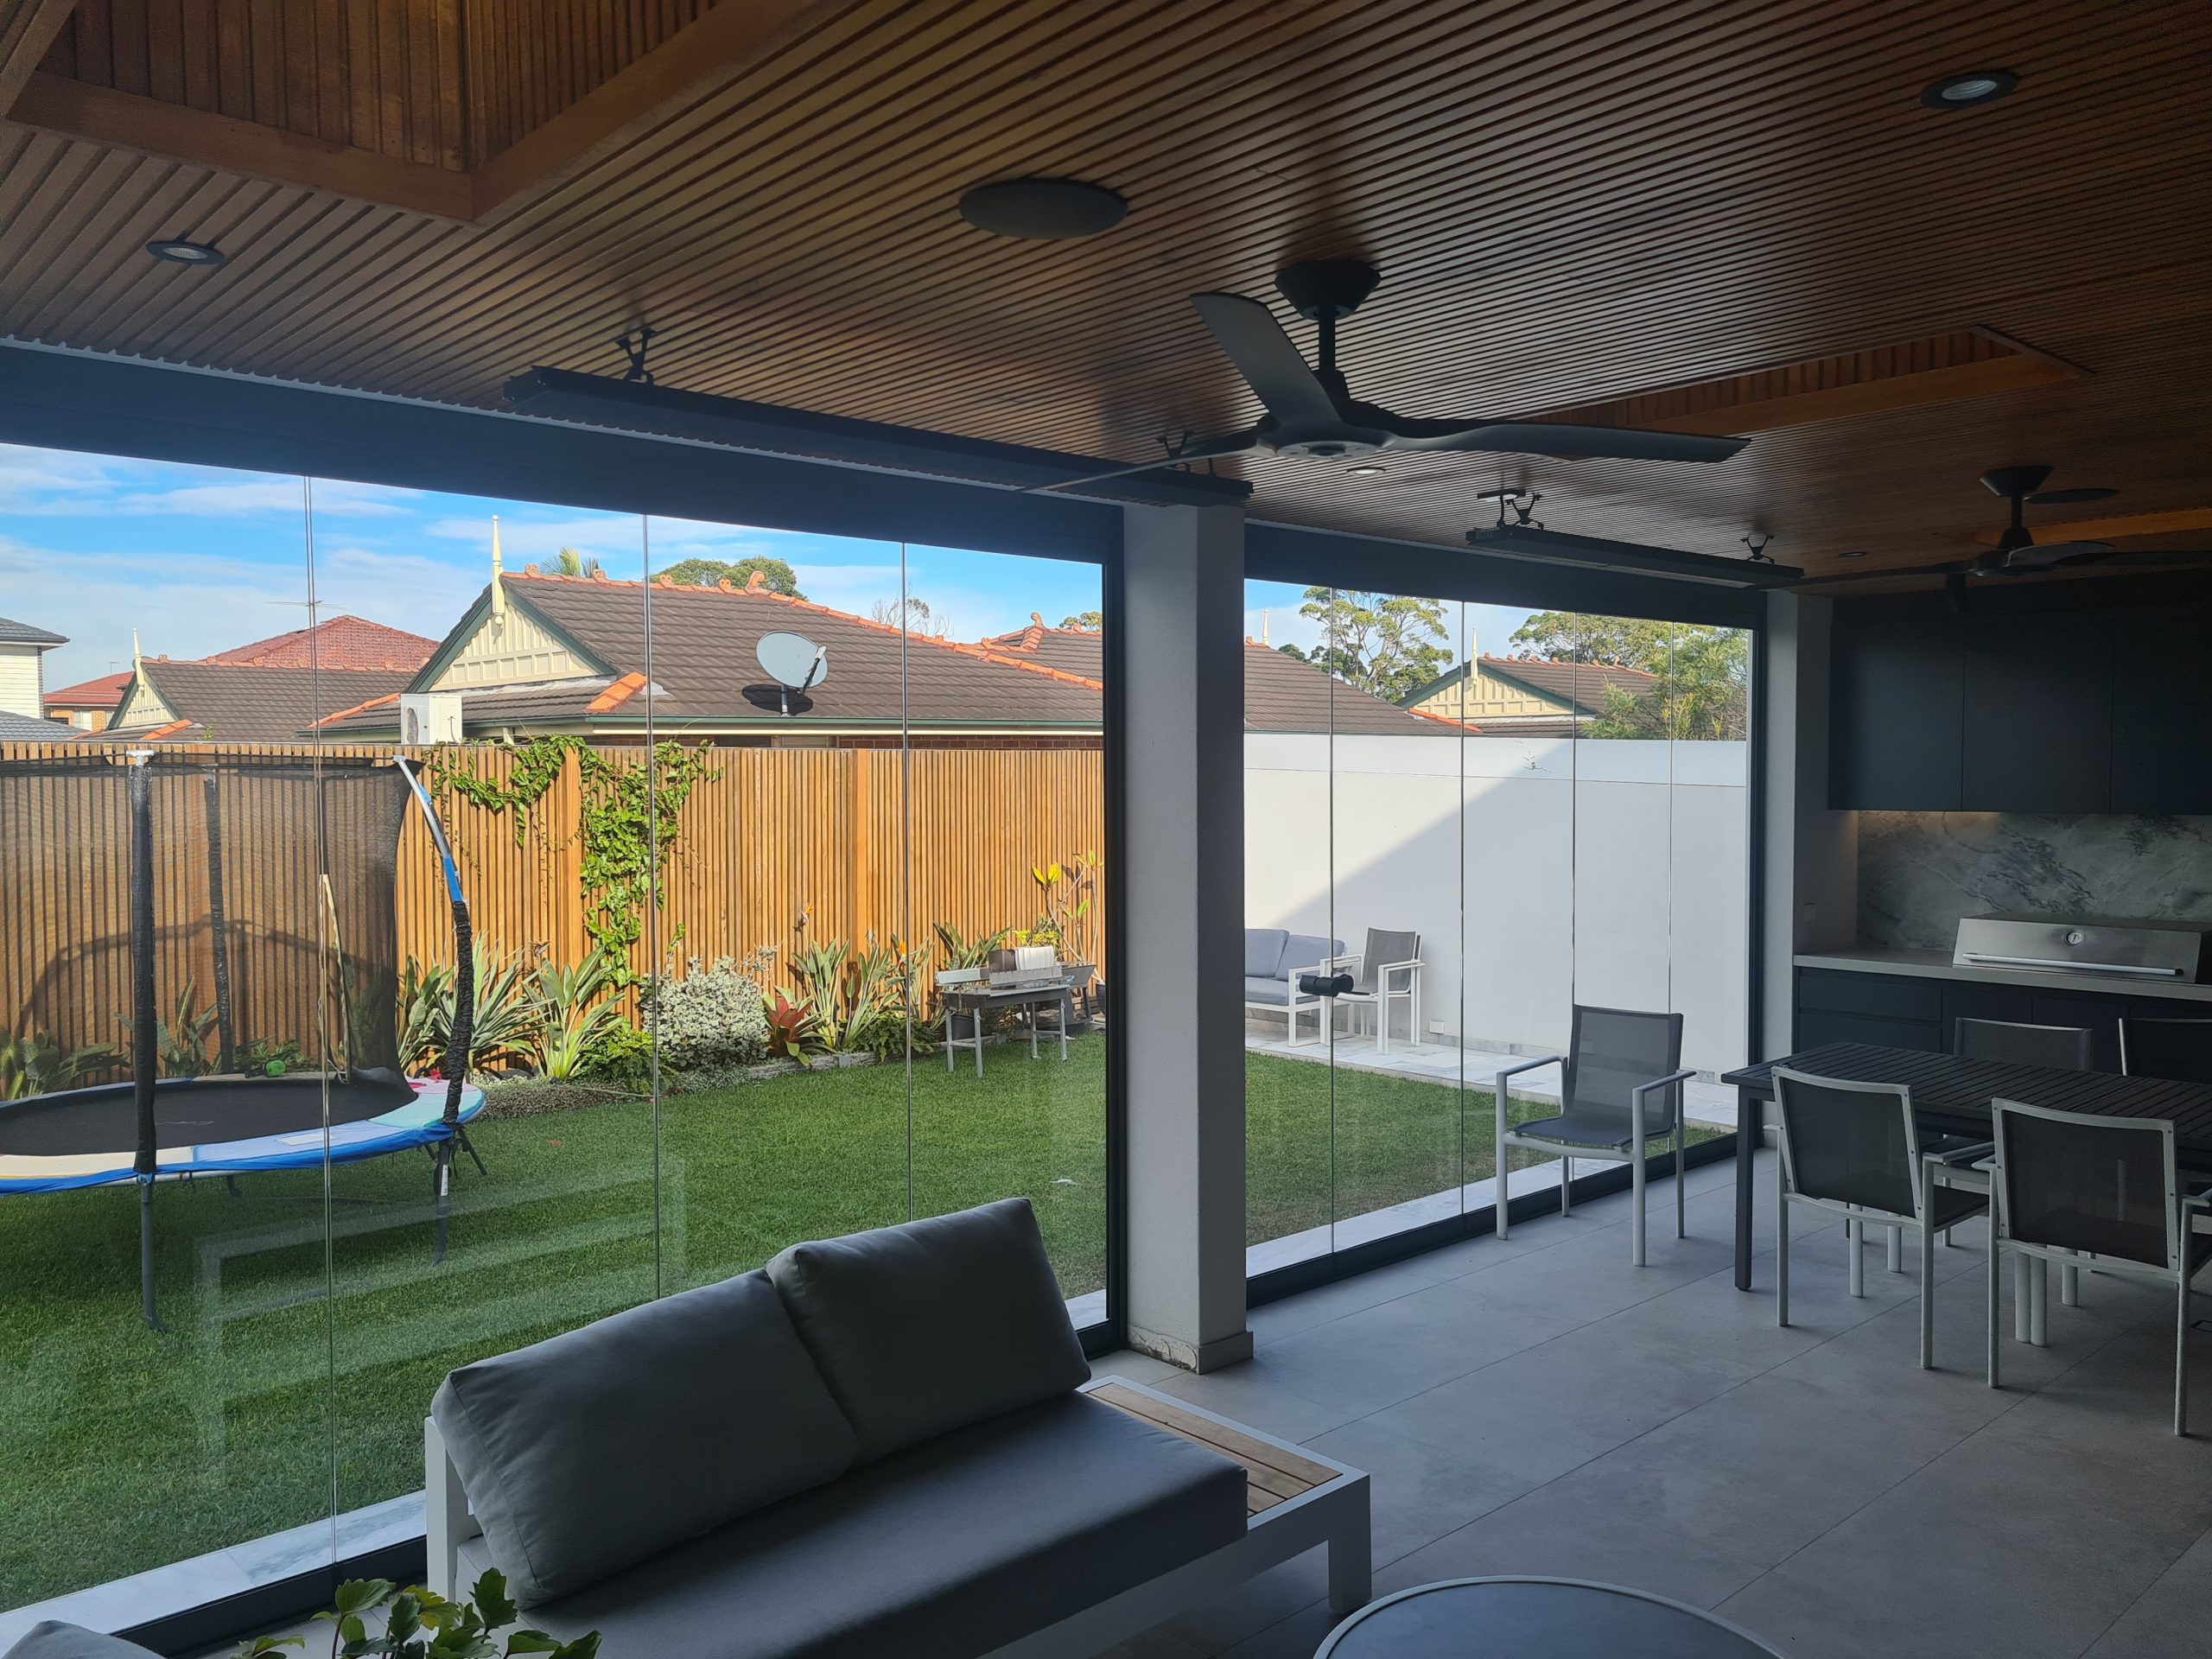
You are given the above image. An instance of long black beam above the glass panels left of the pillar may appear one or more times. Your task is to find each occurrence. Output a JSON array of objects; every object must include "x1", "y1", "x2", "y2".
[{"x1": 0, "y1": 345, "x2": 1122, "y2": 562}]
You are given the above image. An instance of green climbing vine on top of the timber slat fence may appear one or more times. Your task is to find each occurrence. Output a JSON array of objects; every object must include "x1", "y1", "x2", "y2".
[{"x1": 431, "y1": 736, "x2": 721, "y2": 987}]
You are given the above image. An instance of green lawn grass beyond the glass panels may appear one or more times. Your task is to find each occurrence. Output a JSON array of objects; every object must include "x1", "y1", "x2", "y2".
[{"x1": 0, "y1": 1038, "x2": 1716, "y2": 1608}]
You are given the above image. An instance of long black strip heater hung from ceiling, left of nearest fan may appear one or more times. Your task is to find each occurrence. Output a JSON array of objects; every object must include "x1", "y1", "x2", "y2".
[{"x1": 506, "y1": 370, "x2": 1252, "y2": 506}]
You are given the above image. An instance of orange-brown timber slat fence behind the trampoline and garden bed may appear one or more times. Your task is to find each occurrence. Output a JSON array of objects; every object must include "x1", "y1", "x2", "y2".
[{"x1": 0, "y1": 743, "x2": 1103, "y2": 1053}]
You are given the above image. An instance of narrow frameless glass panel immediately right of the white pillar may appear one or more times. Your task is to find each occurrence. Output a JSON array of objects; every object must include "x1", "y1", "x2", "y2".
[{"x1": 1243, "y1": 582, "x2": 1347, "y2": 1272}]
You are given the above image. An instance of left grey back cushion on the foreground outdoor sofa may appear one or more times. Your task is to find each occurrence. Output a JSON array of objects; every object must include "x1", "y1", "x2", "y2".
[{"x1": 431, "y1": 1272, "x2": 858, "y2": 1606}]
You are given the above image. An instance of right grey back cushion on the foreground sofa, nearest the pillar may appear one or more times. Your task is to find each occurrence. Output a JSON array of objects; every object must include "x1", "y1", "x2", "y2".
[{"x1": 767, "y1": 1199, "x2": 1090, "y2": 1462}]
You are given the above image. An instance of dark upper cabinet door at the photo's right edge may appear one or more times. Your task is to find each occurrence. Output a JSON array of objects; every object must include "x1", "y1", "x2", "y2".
[{"x1": 2113, "y1": 606, "x2": 2212, "y2": 812}]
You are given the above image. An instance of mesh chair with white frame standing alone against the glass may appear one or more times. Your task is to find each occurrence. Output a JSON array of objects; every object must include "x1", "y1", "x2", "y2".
[{"x1": 1496, "y1": 1002, "x2": 1697, "y2": 1268}]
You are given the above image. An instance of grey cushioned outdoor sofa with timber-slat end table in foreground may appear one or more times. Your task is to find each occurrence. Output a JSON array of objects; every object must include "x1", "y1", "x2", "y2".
[{"x1": 425, "y1": 1199, "x2": 1370, "y2": 1659}]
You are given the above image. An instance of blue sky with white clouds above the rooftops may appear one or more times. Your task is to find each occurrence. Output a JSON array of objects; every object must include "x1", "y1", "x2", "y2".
[{"x1": 0, "y1": 445, "x2": 1526, "y2": 688}]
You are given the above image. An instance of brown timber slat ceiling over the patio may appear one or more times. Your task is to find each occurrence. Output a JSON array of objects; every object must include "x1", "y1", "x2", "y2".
[{"x1": 0, "y1": 0, "x2": 2212, "y2": 570}]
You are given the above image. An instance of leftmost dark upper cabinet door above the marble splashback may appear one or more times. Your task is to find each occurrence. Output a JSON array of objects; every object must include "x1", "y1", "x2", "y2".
[{"x1": 1827, "y1": 606, "x2": 1967, "y2": 812}]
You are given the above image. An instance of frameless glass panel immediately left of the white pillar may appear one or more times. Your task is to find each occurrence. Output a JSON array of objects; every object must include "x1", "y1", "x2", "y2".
[{"x1": 898, "y1": 546, "x2": 1115, "y2": 1325}]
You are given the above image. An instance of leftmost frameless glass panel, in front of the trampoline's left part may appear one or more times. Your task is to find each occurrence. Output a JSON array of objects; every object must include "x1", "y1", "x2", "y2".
[{"x1": 0, "y1": 449, "x2": 332, "y2": 1643}]
